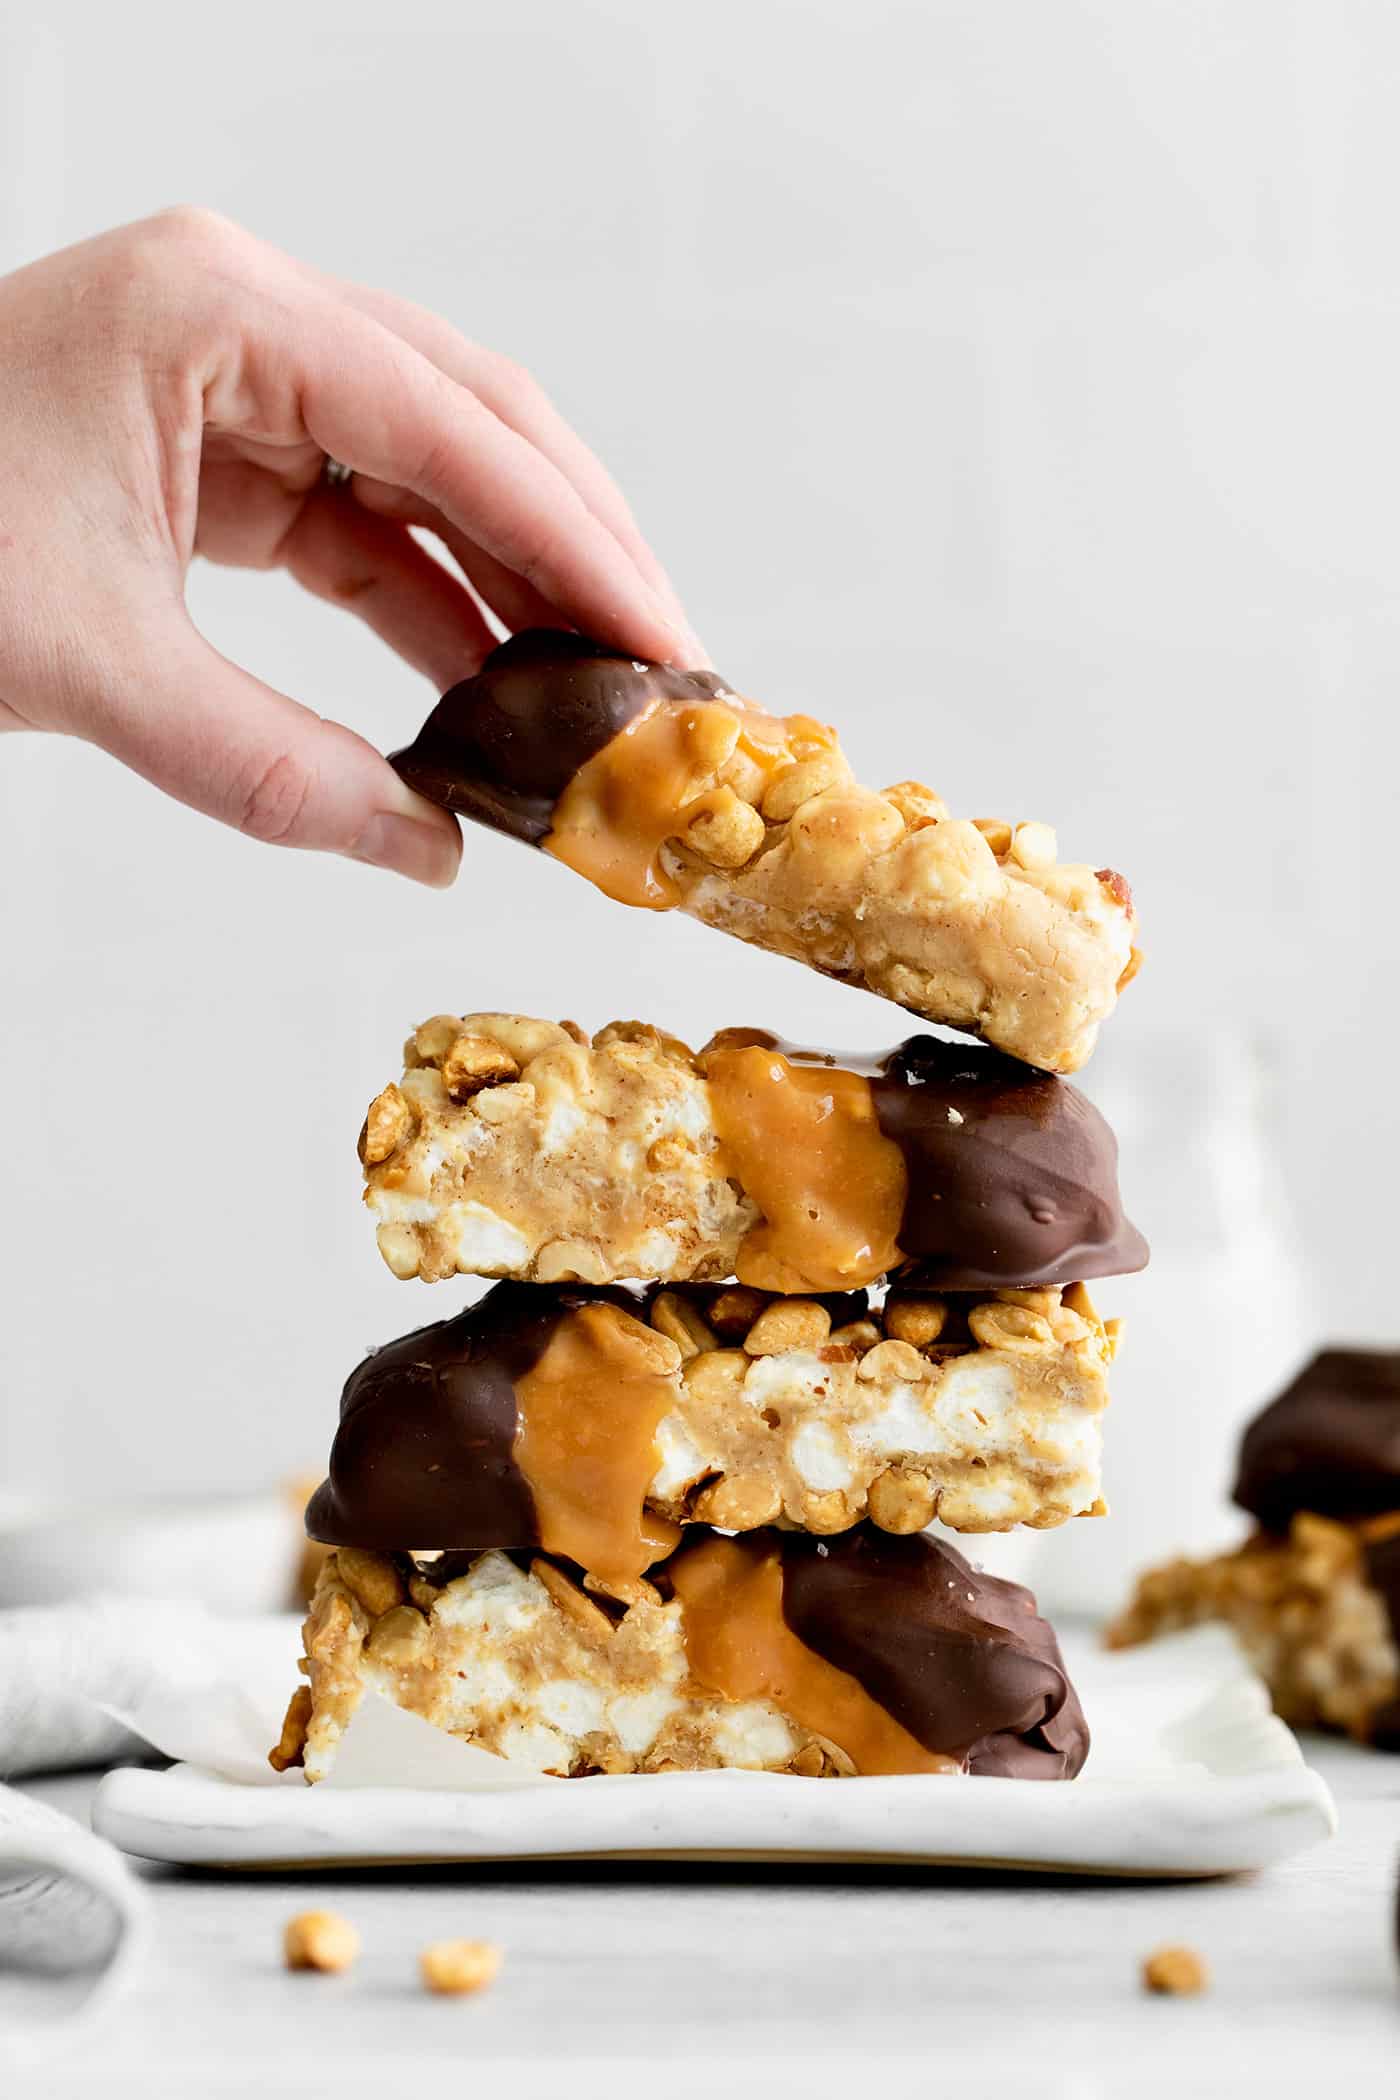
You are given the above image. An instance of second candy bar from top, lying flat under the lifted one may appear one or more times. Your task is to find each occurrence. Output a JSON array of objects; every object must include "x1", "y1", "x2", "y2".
[{"x1": 359, "y1": 1014, "x2": 1148, "y2": 1292}]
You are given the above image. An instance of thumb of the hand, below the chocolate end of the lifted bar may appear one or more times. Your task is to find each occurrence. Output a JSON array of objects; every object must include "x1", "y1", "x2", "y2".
[{"x1": 82, "y1": 622, "x2": 462, "y2": 888}]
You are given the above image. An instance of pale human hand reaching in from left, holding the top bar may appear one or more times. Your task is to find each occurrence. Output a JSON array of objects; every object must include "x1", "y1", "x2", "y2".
[{"x1": 0, "y1": 208, "x2": 703, "y2": 886}]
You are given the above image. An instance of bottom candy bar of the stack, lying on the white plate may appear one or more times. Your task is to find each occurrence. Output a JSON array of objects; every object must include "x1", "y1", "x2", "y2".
[{"x1": 275, "y1": 1527, "x2": 1089, "y2": 1781}]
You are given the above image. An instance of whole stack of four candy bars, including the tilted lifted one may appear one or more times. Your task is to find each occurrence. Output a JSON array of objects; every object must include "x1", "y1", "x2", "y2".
[{"x1": 273, "y1": 634, "x2": 1146, "y2": 1779}]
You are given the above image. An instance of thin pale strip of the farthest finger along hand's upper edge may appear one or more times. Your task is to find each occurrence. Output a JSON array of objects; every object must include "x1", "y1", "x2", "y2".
[{"x1": 329, "y1": 281, "x2": 701, "y2": 624}]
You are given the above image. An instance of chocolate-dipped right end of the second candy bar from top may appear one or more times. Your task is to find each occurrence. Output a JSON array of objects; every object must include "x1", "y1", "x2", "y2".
[{"x1": 871, "y1": 1035, "x2": 1148, "y2": 1292}]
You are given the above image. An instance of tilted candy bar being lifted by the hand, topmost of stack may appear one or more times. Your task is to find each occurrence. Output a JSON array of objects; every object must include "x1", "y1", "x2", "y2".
[{"x1": 395, "y1": 630, "x2": 1138, "y2": 1071}]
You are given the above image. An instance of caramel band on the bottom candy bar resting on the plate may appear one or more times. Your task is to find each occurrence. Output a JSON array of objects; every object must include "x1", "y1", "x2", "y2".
[{"x1": 672, "y1": 1537, "x2": 957, "y2": 1772}]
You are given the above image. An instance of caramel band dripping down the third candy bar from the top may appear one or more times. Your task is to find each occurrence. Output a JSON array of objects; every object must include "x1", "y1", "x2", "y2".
[{"x1": 514, "y1": 1304, "x2": 680, "y2": 1581}]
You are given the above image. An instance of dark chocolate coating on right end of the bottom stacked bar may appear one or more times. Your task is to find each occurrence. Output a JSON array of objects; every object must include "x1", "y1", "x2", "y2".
[{"x1": 776, "y1": 1525, "x2": 1089, "y2": 1779}]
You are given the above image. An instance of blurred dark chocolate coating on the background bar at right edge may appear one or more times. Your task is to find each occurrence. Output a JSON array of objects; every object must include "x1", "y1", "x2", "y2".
[{"x1": 1234, "y1": 1348, "x2": 1400, "y2": 1533}]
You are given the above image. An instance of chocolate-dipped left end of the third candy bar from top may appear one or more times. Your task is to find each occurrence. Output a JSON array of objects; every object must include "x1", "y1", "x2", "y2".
[{"x1": 306, "y1": 1283, "x2": 636, "y2": 1552}]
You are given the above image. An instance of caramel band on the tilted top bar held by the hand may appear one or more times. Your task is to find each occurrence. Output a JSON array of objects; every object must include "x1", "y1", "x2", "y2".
[{"x1": 542, "y1": 697, "x2": 835, "y2": 911}]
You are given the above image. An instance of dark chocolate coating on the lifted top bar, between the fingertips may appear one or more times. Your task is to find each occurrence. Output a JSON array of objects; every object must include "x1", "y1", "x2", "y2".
[{"x1": 388, "y1": 628, "x2": 726, "y2": 846}]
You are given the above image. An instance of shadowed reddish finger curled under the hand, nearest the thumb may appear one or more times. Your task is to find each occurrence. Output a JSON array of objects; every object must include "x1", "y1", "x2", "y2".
[{"x1": 279, "y1": 487, "x2": 495, "y2": 691}]
